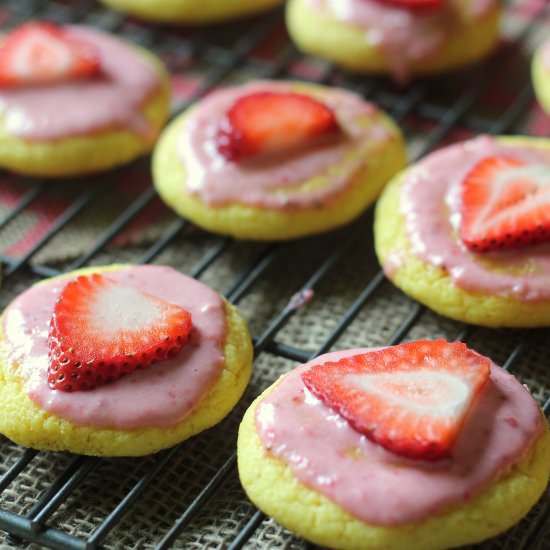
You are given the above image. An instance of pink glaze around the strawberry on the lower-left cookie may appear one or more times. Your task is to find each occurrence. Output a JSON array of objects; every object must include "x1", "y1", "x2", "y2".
[{"x1": 4, "y1": 265, "x2": 225, "y2": 429}]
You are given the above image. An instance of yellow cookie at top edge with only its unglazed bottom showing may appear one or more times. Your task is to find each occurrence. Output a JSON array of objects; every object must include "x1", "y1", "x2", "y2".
[{"x1": 101, "y1": 0, "x2": 283, "y2": 24}]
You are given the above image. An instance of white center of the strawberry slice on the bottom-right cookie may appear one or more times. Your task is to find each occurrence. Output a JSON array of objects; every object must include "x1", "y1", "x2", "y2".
[{"x1": 345, "y1": 372, "x2": 471, "y2": 416}]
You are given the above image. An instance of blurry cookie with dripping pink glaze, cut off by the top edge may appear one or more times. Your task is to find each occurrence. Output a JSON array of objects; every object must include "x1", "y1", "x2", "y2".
[{"x1": 287, "y1": 0, "x2": 501, "y2": 80}]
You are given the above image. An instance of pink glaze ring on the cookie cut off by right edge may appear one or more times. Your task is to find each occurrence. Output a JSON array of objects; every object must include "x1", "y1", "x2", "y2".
[{"x1": 401, "y1": 136, "x2": 550, "y2": 301}]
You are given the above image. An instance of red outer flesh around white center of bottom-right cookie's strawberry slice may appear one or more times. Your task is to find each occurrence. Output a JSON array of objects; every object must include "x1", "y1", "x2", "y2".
[{"x1": 301, "y1": 340, "x2": 491, "y2": 461}]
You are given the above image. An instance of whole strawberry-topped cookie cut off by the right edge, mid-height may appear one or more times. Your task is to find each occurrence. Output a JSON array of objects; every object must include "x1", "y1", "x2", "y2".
[{"x1": 375, "y1": 136, "x2": 550, "y2": 327}]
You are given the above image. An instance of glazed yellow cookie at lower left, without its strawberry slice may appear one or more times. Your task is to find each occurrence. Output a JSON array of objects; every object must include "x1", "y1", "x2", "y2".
[{"x1": 0, "y1": 265, "x2": 252, "y2": 456}]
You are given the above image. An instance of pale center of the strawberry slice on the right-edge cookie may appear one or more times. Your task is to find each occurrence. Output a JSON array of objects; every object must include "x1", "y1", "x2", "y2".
[{"x1": 472, "y1": 164, "x2": 550, "y2": 234}]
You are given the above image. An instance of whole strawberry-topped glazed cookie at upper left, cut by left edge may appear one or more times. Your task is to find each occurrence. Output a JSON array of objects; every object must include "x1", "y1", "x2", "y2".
[{"x1": 0, "y1": 22, "x2": 169, "y2": 177}]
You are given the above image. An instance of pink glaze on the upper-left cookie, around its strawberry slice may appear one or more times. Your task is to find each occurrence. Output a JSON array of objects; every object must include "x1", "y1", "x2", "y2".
[{"x1": 0, "y1": 26, "x2": 160, "y2": 141}]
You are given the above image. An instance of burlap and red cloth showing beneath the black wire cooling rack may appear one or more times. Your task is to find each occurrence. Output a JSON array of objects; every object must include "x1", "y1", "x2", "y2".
[{"x1": 0, "y1": 0, "x2": 550, "y2": 550}]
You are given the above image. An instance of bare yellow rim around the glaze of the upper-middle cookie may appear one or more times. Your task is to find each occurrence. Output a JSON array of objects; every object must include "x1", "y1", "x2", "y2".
[{"x1": 153, "y1": 81, "x2": 407, "y2": 241}]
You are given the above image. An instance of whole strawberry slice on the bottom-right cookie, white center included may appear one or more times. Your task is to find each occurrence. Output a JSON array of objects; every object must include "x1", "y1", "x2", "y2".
[{"x1": 302, "y1": 340, "x2": 491, "y2": 460}]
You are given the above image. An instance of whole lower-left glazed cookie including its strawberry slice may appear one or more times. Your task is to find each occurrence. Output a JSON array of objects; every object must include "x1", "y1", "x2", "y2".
[{"x1": 0, "y1": 265, "x2": 252, "y2": 456}]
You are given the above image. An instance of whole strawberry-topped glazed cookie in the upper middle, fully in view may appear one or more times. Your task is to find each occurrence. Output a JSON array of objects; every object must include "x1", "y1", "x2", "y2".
[{"x1": 153, "y1": 81, "x2": 406, "y2": 240}]
